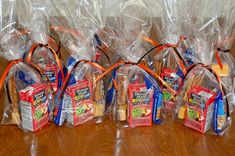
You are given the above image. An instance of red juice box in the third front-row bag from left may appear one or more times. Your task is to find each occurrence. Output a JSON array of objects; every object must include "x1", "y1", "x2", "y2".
[{"x1": 128, "y1": 83, "x2": 153, "y2": 127}]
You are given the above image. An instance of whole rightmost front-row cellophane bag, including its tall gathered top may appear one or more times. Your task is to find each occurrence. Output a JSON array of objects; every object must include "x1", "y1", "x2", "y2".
[{"x1": 175, "y1": 1, "x2": 231, "y2": 135}]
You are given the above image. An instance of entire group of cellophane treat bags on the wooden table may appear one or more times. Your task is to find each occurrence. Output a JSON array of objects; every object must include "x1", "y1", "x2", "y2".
[{"x1": 0, "y1": 0, "x2": 235, "y2": 134}]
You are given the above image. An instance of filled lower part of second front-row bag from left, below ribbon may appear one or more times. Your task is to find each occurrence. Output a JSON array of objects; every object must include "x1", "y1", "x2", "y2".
[{"x1": 55, "y1": 61, "x2": 105, "y2": 126}]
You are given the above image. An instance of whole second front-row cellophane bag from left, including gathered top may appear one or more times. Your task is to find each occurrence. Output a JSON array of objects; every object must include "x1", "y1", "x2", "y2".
[{"x1": 49, "y1": 0, "x2": 108, "y2": 126}]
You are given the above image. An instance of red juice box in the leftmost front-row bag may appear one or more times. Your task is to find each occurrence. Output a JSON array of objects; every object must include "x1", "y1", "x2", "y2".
[{"x1": 19, "y1": 83, "x2": 49, "y2": 132}]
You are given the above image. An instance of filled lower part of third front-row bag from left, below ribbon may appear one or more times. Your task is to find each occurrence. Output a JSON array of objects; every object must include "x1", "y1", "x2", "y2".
[{"x1": 113, "y1": 66, "x2": 162, "y2": 127}]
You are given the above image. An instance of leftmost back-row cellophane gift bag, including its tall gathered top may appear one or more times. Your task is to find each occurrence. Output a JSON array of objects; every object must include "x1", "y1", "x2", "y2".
[{"x1": 19, "y1": 0, "x2": 66, "y2": 97}]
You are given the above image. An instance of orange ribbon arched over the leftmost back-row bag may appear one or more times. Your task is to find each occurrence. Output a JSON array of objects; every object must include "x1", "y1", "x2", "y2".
[{"x1": 26, "y1": 44, "x2": 65, "y2": 92}]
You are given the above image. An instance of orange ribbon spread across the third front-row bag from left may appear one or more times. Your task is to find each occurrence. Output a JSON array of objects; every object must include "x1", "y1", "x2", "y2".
[{"x1": 95, "y1": 61, "x2": 176, "y2": 95}]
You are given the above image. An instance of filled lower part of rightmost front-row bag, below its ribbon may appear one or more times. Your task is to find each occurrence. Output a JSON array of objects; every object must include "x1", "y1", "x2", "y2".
[{"x1": 176, "y1": 65, "x2": 230, "y2": 135}]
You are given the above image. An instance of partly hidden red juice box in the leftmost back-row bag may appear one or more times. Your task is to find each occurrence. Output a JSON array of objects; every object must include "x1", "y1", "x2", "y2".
[{"x1": 44, "y1": 64, "x2": 59, "y2": 91}]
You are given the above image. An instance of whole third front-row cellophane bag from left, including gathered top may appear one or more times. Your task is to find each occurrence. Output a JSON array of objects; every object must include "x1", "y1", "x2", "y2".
[{"x1": 103, "y1": 0, "x2": 170, "y2": 127}]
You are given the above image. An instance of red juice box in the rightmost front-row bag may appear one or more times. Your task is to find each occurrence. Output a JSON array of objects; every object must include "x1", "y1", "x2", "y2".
[{"x1": 184, "y1": 86, "x2": 216, "y2": 133}]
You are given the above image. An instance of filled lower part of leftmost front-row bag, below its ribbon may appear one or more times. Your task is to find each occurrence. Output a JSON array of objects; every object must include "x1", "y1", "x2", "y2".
[{"x1": 2, "y1": 62, "x2": 50, "y2": 132}]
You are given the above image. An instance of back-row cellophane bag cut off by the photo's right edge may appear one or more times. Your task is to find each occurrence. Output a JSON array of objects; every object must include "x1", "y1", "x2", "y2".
[{"x1": 211, "y1": 0, "x2": 235, "y2": 112}]
